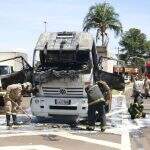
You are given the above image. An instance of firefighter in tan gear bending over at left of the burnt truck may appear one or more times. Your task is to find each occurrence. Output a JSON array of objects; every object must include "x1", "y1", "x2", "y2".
[{"x1": 4, "y1": 82, "x2": 31, "y2": 126}]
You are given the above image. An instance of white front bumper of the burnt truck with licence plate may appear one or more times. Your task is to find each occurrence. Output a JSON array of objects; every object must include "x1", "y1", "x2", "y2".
[{"x1": 31, "y1": 97, "x2": 88, "y2": 118}]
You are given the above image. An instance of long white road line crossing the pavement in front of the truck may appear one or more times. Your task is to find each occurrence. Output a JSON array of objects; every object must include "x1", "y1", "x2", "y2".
[{"x1": 0, "y1": 131, "x2": 121, "y2": 149}]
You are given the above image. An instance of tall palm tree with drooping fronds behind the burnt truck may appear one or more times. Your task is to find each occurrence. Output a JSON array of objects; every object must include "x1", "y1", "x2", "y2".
[{"x1": 83, "y1": 3, "x2": 122, "y2": 46}]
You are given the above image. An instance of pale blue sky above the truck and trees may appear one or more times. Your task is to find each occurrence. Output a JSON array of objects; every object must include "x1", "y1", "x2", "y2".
[{"x1": 0, "y1": 0, "x2": 150, "y2": 62}]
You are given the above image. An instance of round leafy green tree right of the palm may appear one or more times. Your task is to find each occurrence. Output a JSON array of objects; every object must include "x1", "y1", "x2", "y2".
[{"x1": 119, "y1": 28, "x2": 148, "y2": 62}]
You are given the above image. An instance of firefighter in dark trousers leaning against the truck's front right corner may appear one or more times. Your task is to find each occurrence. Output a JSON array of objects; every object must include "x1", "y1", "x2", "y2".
[{"x1": 85, "y1": 81, "x2": 111, "y2": 132}]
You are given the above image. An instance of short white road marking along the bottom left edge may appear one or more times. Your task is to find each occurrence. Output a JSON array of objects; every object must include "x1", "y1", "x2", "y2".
[{"x1": 0, "y1": 145, "x2": 61, "y2": 150}]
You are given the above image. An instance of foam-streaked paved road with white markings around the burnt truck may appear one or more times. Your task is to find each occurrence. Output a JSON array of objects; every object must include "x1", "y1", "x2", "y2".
[{"x1": 0, "y1": 86, "x2": 150, "y2": 150}]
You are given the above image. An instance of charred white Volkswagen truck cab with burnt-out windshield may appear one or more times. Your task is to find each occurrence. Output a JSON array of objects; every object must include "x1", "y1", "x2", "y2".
[{"x1": 31, "y1": 32, "x2": 103, "y2": 122}]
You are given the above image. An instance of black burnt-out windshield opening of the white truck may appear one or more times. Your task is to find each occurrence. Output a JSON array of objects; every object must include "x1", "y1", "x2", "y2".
[{"x1": 38, "y1": 50, "x2": 92, "y2": 71}]
